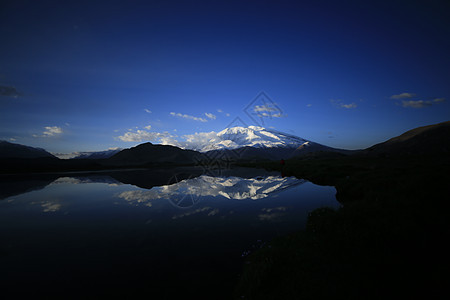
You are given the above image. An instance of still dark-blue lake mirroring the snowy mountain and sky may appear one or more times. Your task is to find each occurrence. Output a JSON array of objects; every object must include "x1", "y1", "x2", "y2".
[{"x1": 0, "y1": 168, "x2": 339, "y2": 299}]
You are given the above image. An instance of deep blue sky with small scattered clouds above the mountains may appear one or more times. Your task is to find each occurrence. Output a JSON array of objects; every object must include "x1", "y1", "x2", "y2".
[{"x1": 0, "y1": 0, "x2": 450, "y2": 153}]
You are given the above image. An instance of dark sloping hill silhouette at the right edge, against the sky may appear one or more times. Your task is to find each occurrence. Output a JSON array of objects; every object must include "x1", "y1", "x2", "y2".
[{"x1": 363, "y1": 121, "x2": 450, "y2": 155}]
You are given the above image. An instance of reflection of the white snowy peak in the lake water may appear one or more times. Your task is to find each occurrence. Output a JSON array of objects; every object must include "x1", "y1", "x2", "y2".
[{"x1": 118, "y1": 175, "x2": 305, "y2": 206}]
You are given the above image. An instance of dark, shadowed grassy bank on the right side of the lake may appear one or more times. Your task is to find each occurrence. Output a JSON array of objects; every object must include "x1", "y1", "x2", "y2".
[{"x1": 236, "y1": 156, "x2": 450, "y2": 299}]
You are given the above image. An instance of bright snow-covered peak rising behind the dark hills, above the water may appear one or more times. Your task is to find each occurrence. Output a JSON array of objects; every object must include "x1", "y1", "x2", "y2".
[{"x1": 186, "y1": 126, "x2": 309, "y2": 152}]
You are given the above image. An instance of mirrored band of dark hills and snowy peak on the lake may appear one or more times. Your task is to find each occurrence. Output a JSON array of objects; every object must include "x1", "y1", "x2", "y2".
[{"x1": 0, "y1": 167, "x2": 288, "y2": 199}]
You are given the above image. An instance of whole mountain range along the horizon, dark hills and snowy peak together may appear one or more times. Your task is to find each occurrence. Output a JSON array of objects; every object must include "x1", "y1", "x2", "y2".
[{"x1": 0, "y1": 121, "x2": 450, "y2": 171}]
